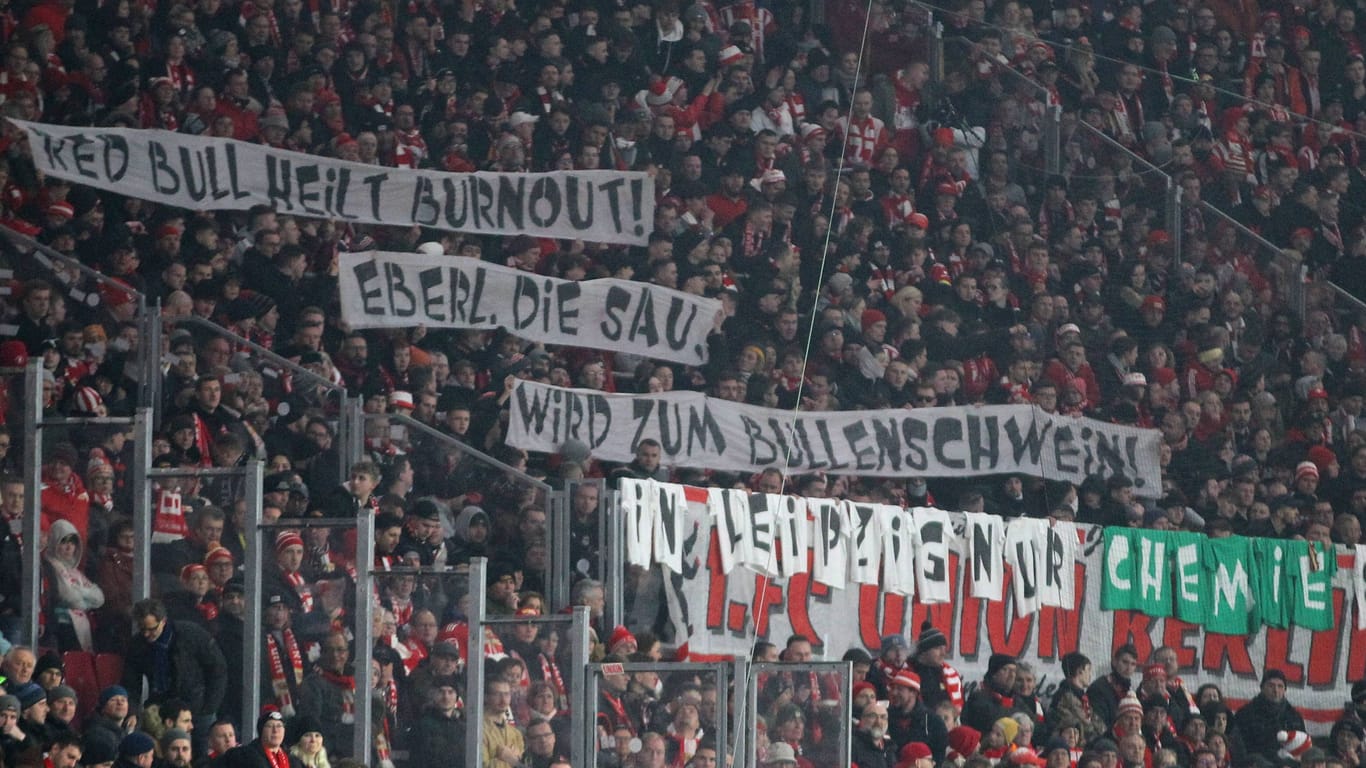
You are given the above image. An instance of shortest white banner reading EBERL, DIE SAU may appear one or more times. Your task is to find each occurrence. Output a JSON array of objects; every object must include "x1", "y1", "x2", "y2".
[{"x1": 337, "y1": 251, "x2": 721, "y2": 365}]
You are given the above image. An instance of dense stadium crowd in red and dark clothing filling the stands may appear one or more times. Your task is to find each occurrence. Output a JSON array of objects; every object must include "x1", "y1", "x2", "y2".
[{"x1": 0, "y1": 0, "x2": 1366, "y2": 768}]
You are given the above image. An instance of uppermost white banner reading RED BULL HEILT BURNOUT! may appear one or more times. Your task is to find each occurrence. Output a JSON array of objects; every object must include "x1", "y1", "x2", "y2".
[{"x1": 10, "y1": 119, "x2": 654, "y2": 245}]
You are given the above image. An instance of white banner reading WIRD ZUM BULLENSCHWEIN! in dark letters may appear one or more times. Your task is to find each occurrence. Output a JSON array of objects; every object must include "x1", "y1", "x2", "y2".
[{"x1": 508, "y1": 381, "x2": 1162, "y2": 491}]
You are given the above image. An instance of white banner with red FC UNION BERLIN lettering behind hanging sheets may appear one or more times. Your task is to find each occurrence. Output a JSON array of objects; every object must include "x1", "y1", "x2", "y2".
[{"x1": 664, "y1": 486, "x2": 1366, "y2": 734}]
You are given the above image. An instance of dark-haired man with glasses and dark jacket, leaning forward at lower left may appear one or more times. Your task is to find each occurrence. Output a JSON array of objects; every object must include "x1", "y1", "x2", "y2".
[{"x1": 123, "y1": 599, "x2": 228, "y2": 730}]
